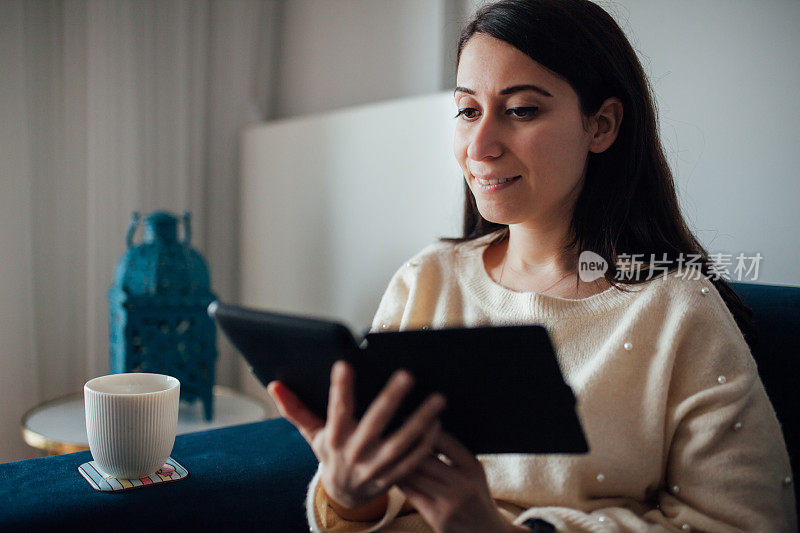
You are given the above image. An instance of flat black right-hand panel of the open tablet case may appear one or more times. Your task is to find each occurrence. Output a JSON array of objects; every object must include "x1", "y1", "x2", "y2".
[{"x1": 358, "y1": 325, "x2": 588, "y2": 453}]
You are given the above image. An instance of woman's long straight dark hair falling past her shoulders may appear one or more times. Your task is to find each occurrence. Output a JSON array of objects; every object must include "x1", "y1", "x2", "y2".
[{"x1": 442, "y1": 0, "x2": 753, "y2": 340}]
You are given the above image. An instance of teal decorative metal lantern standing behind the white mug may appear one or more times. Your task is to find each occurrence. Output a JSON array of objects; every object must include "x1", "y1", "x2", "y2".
[{"x1": 108, "y1": 211, "x2": 217, "y2": 420}]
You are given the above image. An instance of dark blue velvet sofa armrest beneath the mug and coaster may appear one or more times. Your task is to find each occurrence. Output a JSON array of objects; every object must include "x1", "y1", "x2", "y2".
[{"x1": 0, "y1": 419, "x2": 317, "y2": 532}]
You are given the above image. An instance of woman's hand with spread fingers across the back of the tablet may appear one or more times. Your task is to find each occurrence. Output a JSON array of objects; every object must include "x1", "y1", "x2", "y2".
[{"x1": 267, "y1": 361, "x2": 445, "y2": 509}]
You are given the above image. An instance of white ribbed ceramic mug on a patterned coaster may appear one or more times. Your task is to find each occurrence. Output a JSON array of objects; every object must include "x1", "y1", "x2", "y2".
[{"x1": 83, "y1": 373, "x2": 181, "y2": 479}]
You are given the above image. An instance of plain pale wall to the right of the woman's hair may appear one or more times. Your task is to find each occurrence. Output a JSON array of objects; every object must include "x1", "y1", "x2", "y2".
[{"x1": 601, "y1": 0, "x2": 800, "y2": 285}]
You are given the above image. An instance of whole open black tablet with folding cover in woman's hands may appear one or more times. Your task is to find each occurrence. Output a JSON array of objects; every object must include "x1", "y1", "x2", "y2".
[{"x1": 209, "y1": 302, "x2": 588, "y2": 454}]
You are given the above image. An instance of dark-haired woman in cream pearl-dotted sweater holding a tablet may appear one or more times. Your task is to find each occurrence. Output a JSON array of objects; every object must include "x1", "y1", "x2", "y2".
[{"x1": 269, "y1": 0, "x2": 796, "y2": 532}]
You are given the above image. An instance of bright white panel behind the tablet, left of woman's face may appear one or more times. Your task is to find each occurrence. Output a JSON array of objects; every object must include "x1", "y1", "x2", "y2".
[{"x1": 240, "y1": 93, "x2": 462, "y2": 333}]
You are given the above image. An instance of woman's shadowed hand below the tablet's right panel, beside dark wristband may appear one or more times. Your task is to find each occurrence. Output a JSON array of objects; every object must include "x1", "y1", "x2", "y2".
[{"x1": 397, "y1": 432, "x2": 530, "y2": 533}]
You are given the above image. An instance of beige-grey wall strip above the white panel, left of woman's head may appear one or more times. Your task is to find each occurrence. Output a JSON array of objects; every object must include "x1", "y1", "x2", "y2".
[{"x1": 271, "y1": 0, "x2": 468, "y2": 118}]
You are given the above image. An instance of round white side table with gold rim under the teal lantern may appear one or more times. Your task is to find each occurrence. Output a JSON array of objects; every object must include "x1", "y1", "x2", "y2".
[{"x1": 22, "y1": 385, "x2": 272, "y2": 455}]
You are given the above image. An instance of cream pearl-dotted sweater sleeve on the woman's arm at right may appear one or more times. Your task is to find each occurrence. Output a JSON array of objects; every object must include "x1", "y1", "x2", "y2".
[{"x1": 510, "y1": 284, "x2": 797, "y2": 532}]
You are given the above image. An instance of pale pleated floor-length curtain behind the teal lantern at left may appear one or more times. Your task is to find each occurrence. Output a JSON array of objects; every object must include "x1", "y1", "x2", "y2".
[{"x1": 0, "y1": 0, "x2": 279, "y2": 462}]
